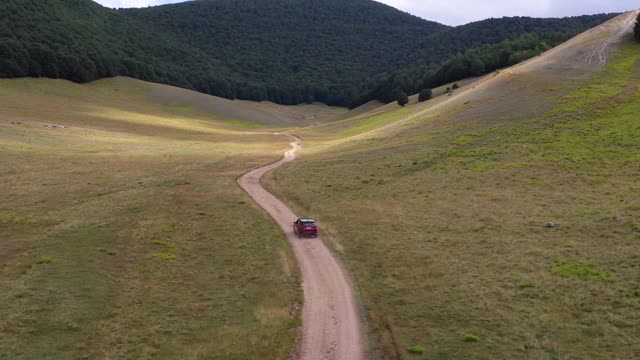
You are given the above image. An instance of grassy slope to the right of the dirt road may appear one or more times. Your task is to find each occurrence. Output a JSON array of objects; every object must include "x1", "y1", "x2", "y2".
[{"x1": 267, "y1": 43, "x2": 640, "y2": 359}]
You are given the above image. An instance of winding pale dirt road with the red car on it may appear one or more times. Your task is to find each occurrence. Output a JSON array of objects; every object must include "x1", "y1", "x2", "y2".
[{"x1": 238, "y1": 137, "x2": 363, "y2": 360}]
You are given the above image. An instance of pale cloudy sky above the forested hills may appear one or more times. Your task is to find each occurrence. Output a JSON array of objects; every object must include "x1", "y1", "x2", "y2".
[{"x1": 94, "y1": 0, "x2": 640, "y2": 25}]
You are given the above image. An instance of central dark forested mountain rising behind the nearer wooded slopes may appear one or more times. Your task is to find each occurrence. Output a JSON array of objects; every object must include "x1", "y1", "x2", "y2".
[{"x1": 121, "y1": 0, "x2": 448, "y2": 105}]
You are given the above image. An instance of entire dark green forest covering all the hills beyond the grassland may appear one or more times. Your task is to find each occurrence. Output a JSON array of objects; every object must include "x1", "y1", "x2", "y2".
[{"x1": 0, "y1": 0, "x2": 613, "y2": 106}]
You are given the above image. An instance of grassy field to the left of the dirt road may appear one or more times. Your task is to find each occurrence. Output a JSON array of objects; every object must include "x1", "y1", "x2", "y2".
[{"x1": 0, "y1": 79, "x2": 302, "y2": 359}]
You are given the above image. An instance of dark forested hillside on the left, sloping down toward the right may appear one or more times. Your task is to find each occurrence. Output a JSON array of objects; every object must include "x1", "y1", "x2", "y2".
[{"x1": 0, "y1": 0, "x2": 244, "y2": 91}]
